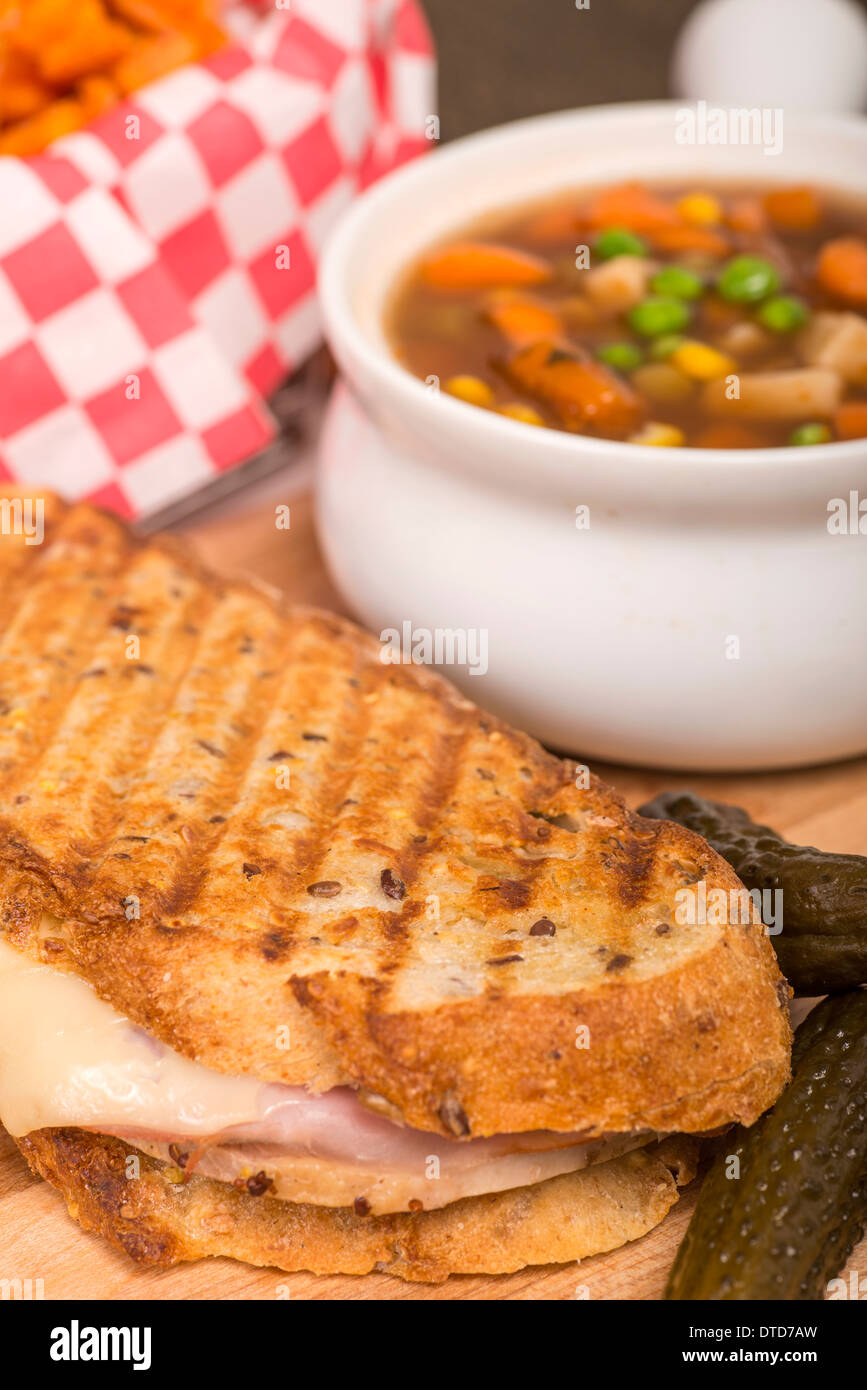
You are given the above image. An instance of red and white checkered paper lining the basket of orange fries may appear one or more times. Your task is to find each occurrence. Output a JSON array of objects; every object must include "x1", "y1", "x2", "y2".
[{"x1": 0, "y1": 0, "x2": 434, "y2": 518}]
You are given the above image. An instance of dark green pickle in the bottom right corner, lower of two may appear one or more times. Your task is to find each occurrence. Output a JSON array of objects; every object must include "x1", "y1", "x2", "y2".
[{"x1": 664, "y1": 990, "x2": 867, "y2": 1302}]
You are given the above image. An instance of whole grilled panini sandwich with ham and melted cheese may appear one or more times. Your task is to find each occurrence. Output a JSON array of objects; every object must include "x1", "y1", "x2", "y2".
[{"x1": 0, "y1": 496, "x2": 791, "y2": 1280}]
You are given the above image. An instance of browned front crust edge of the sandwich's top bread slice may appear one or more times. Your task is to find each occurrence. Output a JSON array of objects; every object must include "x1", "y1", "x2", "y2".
[{"x1": 293, "y1": 917, "x2": 788, "y2": 1137}]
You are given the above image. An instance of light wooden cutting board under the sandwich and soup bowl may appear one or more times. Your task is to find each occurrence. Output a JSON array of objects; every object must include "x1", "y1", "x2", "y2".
[{"x1": 0, "y1": 478, "x2": 867, "y2": 1300}]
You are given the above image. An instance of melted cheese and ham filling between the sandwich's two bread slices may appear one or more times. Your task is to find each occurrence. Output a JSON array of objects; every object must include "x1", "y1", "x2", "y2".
[{"x1": 0, "y1": 942, "x2": 650, "y2": 1212}]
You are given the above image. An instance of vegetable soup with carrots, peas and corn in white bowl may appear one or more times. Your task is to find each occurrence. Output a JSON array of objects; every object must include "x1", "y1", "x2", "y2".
[{"x1": 388, "y1": 182, "x2": 867, "y2": 449}]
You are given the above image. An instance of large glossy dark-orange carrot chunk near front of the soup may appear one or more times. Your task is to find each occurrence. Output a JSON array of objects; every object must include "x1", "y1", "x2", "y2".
[{"x1": 504, "y1": 341, "x2": 645, "y2": 434}]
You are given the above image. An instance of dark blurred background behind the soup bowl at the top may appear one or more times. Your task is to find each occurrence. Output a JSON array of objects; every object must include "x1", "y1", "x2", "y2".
[{"x1": 421, "y1": 0, "x2": 867, "y2": 140}]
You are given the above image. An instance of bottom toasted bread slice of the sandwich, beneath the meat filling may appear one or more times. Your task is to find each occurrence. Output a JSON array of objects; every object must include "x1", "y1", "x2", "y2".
[{"x1": 15, "y1": 1129, "x2": 697, "y2": 1283}]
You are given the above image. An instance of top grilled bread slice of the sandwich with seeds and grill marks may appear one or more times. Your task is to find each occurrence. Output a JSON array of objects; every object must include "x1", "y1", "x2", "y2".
[{"x1": 0, "y1": 498, "x2": 791, "y2": 1138}]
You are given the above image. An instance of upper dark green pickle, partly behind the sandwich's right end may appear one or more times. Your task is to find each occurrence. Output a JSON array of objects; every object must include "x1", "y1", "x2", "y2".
[{"x1": 639, "y1": 791, "x2": 867, "y2": 994}]
